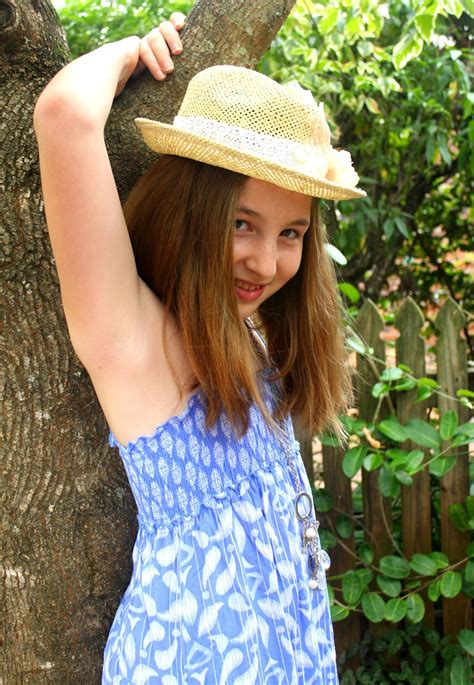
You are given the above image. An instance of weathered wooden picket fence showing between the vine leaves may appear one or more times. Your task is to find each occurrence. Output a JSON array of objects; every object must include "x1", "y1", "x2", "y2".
[{"x1": 303, "y1": 298, "x2": 472, "y2": 653}]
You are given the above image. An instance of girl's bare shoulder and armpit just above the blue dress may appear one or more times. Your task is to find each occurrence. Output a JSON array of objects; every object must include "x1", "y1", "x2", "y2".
[{"x1": 87, "y1": 284, "x2": 192, "y2": 444}]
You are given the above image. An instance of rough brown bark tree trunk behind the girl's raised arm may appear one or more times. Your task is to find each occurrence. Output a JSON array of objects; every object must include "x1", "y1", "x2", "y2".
[{"x1": 0, "y1": 0, "x2": 294, "y2": 685}]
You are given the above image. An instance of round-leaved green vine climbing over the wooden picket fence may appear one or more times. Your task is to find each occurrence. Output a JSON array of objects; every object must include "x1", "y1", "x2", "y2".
[{"x1": 315, "y1": 340, "x2": 474, "y2": 685}]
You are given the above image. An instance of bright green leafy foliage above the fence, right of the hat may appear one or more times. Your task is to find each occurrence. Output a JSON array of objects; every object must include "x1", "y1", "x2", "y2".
[{"x1": 261, "y1": 0, "x2": 474, "y2": 302}]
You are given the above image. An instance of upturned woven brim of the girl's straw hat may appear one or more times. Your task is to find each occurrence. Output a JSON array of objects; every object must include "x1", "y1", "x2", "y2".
[{"x1": 135, "y1": 118, "x2": 366, "y2": 200}]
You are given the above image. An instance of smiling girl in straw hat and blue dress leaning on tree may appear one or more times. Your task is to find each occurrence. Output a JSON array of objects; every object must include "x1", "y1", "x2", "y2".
[{"x1": 35, "y1": 14, "x2": 364, "y2": 685}]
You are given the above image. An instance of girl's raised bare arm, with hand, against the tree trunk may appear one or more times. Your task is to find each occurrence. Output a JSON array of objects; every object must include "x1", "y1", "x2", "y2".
[{"x1": 34, "y1": 14, "x2": 184, "y2": 371}]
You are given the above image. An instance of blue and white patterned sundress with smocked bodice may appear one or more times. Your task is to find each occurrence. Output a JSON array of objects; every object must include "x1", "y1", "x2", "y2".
[{"x1": 102, "y1": 392, "x2": 337, "y2": 685}]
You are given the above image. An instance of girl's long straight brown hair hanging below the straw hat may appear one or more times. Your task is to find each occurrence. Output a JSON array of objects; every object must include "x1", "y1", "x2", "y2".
[{"x1": 124, "y1": 155, "x2": 350, "y2": 432}]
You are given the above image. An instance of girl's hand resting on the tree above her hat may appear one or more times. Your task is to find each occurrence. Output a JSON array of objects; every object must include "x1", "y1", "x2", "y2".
[{"x1": 134, "y1": 12, "x2": 186, "y2": 81}]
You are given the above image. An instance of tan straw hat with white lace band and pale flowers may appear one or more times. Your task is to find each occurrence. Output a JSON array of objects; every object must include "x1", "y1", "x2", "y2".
[{"x1": 135, "y1": 66, "x2": 365, "y2": 200}]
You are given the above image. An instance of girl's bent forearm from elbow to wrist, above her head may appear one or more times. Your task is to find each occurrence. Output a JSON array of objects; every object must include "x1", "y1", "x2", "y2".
[{"x1": 35, "y1": 36, "x2": 140, "y2": 135}]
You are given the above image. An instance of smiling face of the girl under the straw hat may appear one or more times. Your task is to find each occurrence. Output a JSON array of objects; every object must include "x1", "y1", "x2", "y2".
[{"x1": 234, "y1": 178, "x2": 311, "y2": 318}]
